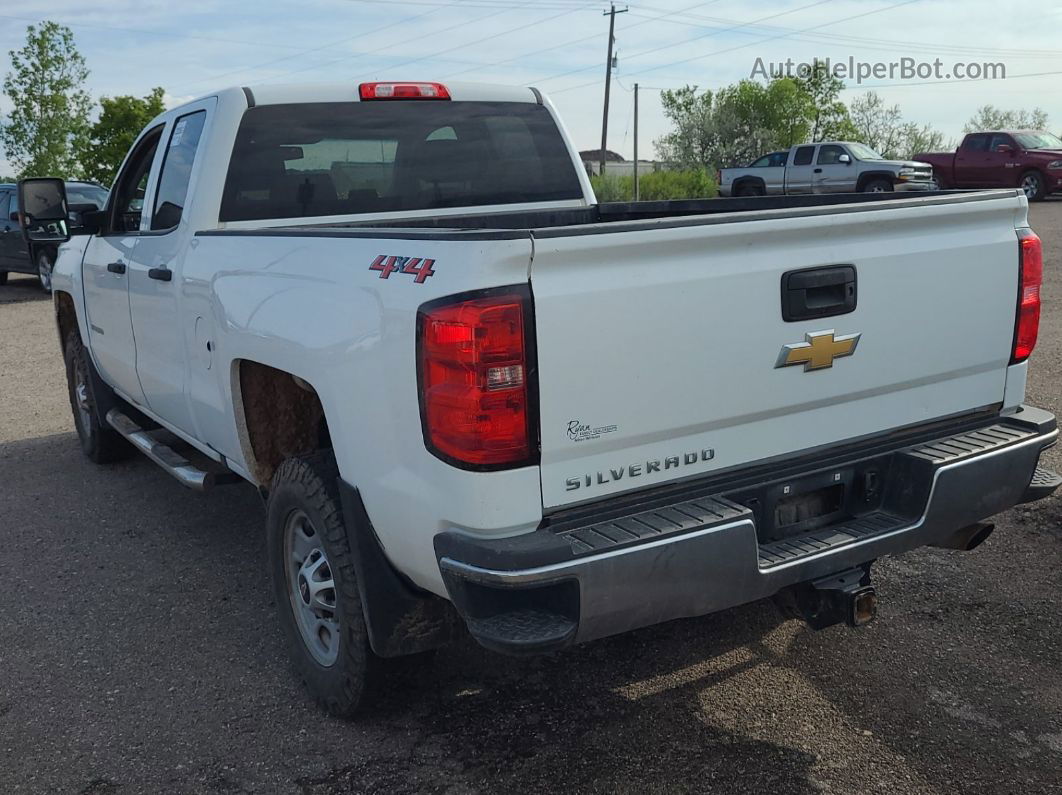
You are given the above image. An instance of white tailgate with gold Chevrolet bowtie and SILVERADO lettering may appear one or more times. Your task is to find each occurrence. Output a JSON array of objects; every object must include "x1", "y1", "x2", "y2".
[{"x1": 531, "y1": 193, "x2": 1024, "y2": 508}]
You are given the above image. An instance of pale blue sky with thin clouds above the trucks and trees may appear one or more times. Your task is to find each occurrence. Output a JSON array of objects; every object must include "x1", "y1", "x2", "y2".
[{"x1": 0, "y1": 0, "x2": 1062, "y2": 173}]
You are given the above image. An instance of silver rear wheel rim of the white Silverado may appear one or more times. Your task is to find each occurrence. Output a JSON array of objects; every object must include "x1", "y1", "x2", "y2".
[{"x1": 284, "y1": 509, "x2": 340, "y2": 668}]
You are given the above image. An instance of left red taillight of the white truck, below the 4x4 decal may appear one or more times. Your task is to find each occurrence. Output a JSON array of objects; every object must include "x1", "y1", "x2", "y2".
[{"x1": 417, "y1": 289, "x2": 536, "y2": 469}]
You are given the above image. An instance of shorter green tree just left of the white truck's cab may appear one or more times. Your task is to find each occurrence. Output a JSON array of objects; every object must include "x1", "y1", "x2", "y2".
[{"x1": 78, "y1": 88, "x2": 166, "y2": 185}]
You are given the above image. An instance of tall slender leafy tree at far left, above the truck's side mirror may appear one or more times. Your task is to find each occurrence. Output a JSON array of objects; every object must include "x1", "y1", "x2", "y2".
[{"x1": 0, "y1": 21, "x2": 92, "y2": 177}]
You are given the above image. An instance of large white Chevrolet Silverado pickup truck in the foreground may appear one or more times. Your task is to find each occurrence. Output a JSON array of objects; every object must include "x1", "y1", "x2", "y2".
[{"x1": 19, "y1": 83, "x2": 1060, "y2": 714}]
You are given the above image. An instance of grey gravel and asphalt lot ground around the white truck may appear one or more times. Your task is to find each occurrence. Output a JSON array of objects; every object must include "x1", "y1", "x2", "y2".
[{"x1": 6, "y1": 201, "x2": 1062, "y2": 793}]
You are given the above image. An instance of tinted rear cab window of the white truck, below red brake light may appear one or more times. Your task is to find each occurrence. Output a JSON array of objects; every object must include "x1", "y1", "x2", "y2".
[{"x1": 220, "y1": 102, "x2": 583, "y2": 222}]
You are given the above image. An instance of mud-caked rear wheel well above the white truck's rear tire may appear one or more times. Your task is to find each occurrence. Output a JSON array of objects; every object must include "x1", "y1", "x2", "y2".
[{"x1": 234, "y1": 360, "x2": 332, "y2": 486}]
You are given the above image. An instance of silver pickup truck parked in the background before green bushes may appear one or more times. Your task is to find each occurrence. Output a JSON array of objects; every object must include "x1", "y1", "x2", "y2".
[{"x1": 716, "y1": 141, "x2": 936, "y2": 196}]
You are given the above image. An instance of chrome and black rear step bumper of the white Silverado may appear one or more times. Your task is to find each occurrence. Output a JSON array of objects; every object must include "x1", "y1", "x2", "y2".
[{"x1": 435, "y1": 407, "x2": 1062, "y2": 654}]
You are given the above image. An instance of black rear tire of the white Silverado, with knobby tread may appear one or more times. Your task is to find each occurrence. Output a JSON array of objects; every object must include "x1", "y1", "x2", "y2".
[{"x1": 266, "y1": 451, "x2": 379, "y2": 718}]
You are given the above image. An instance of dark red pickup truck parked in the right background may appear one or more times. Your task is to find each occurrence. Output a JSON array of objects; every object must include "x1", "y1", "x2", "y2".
[{"x1": 913, "y1": 129, "x2": 1062, "y2": 202}]
